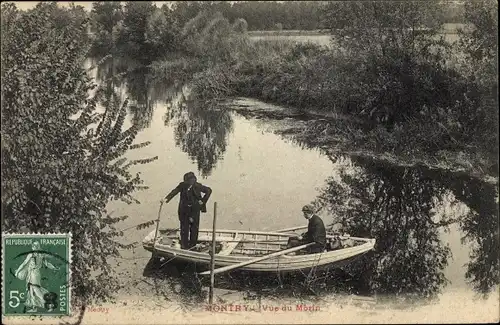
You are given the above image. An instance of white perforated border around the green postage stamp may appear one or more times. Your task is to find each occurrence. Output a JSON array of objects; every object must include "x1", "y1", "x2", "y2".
[{"x1": 2, "y1": 232, "x2": 73, "y2": 317}]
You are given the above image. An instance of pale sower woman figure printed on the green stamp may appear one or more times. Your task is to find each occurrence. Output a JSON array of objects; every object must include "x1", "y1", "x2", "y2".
[{"x1": 14, "y1": 241, "x2": 59, "y2": 312}]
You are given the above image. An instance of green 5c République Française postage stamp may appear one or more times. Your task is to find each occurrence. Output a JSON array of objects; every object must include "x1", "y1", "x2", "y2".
[{"x1": 2, "y1": 233, "x2": 71, "y2": 316}]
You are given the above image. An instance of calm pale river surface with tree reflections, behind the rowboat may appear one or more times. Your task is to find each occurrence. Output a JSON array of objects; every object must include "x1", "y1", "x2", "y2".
[{"x1": 89, "y1": 58, "x2": 499, "y2": 304}]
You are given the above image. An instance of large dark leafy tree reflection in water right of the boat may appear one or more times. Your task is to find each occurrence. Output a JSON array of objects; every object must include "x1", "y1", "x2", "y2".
[{"x1": 318, "y1": 156, "x2": 450, "y2": 296}]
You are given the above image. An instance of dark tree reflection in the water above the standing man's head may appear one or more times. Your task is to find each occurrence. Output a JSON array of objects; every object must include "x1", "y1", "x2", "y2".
[{"x1": 97, "y1": 59, "x2": 233, "y2": 176}]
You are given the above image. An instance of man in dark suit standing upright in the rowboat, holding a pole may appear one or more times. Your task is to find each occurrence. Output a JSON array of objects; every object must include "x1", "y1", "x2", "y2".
[{"x1": 165, "y1": 172, "x2": 212, "y2": 249}]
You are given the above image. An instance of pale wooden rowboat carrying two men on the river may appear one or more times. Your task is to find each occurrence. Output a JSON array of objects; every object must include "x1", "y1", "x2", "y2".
[{"x1": 143, "y1": 227, "x2": 375, "y2": 272}]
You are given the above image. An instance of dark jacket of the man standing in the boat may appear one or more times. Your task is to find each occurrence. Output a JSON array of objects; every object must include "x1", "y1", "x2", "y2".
[{"x1": 165, "y1": 182, "x2": 212, "y2": 214}]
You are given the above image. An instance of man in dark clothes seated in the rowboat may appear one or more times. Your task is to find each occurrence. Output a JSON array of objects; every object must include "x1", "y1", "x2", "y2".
[{"x1": 298, "y1": 205, "x2": 326, "y2": 254}]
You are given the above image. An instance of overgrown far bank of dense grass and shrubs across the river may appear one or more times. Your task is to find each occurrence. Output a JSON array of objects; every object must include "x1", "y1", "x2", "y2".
[{"x1": 187, "y1": 35, "x2": 497, "y2": 181}]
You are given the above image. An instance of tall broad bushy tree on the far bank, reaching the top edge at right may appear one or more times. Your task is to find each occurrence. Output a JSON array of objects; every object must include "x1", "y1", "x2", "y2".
[{"x1": 316, "y1": 1, "x2": 488, "y2": 144}]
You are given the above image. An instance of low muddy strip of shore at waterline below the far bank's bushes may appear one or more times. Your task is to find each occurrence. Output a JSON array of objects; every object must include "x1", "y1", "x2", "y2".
[{"x1": 225, "y1": 97, "x2": 498, "y2": 184}]
